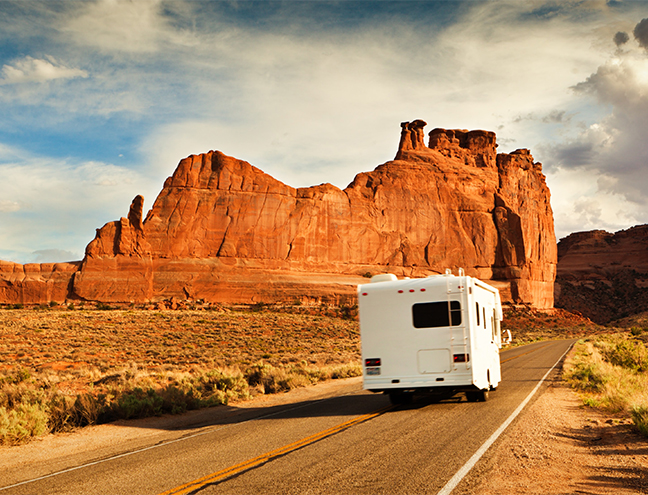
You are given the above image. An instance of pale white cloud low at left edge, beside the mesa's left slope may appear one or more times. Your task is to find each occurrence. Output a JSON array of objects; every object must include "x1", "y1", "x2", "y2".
[{"x1": 0, "y1": 153, "x2": 152, "y2": 263}]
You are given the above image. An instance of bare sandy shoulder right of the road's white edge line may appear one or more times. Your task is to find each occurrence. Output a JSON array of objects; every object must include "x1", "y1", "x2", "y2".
[{"x1": 460, "y1": 377, "x2": 648, "y2": 495}]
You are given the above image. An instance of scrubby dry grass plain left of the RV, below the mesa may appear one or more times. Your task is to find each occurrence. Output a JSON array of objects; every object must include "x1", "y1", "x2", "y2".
[{"x1": 0, "y1": 307, "x2": 361, "y2": 444}]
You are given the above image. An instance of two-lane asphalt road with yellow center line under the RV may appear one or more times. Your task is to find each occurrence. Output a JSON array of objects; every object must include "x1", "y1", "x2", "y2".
[{"x1": 0, "y1": 341, "x2": 571, "y2": 495}]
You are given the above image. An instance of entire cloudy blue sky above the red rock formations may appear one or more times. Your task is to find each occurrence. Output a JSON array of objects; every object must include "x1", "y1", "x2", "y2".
[{"x1": 0, "y1": 0, "x2": 648, "y2": 263}]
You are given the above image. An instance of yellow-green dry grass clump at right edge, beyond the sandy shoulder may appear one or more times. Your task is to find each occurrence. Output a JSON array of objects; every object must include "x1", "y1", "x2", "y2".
[{"x1": 564, "y1": 332, "x2": 648, "y2": 436}]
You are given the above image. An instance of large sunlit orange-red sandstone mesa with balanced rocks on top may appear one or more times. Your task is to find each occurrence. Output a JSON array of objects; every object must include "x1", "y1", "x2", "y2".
[{"x1": 0, "y1": 120, "x2": 557, "y2": 308}]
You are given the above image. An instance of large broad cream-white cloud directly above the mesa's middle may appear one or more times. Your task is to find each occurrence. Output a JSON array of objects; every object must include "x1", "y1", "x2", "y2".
[{"x1": 141, "y1": 2, "x2": 616, "y2": 191}]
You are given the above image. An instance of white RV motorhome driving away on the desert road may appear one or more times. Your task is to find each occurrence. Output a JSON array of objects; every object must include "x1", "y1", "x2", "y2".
[{"x1": 358, "y1": 269, "x2": 502, "y2": 403}]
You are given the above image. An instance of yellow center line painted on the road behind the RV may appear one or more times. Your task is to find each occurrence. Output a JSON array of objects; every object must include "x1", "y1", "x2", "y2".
[{"x1": 160, "y1": 406, "x2": 394, "y2": 495}]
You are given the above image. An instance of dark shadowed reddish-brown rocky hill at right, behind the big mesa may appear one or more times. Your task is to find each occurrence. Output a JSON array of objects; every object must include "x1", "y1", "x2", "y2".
[{"x1": 556, "y1": 225, "x2": 648, "y2": 323}]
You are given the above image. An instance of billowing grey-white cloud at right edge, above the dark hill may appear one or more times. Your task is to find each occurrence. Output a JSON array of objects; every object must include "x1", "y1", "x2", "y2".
[{"x1": 548, "y1": 34, "x2": 648, "y2": 219}]
